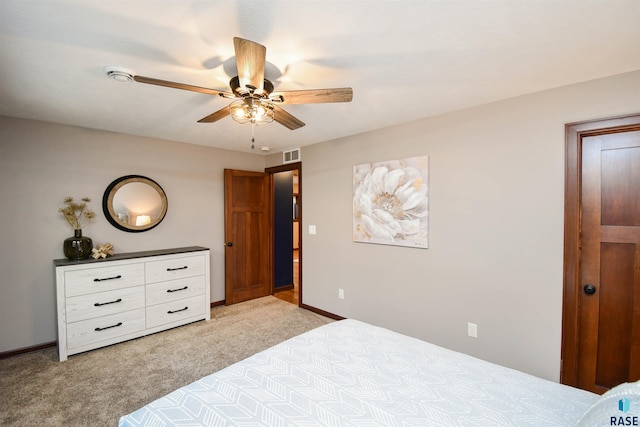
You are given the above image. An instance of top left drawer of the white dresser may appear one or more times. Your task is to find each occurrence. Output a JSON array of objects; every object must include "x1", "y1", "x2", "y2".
[{"x1": 64, "y1": 263, "x2": 144, "y2": 297}]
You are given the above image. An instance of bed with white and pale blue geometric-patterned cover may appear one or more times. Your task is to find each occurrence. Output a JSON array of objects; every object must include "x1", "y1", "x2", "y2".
[{"x1": 119, "y1": 320, "x2": 609, "y2": 427}]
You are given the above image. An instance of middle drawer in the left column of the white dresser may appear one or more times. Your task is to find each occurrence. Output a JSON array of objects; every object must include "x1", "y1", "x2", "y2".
[{"x1": 65, "y1": 286, "x2": 145, "y2": 322}]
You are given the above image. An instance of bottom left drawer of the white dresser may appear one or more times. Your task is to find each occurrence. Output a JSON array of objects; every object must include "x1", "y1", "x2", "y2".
[{"x1": 67, "y1": 308, "x2": 145, "y2": 351}]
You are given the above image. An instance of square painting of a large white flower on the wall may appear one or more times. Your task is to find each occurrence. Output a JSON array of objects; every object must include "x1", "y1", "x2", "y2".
[{"x1": 353, "y1": 156, "x2": 429, "y2": 248}]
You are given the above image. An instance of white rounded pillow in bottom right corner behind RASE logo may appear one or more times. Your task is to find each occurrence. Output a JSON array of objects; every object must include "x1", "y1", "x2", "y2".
[{"x1": 576, "y1": 381, "x2": 640, "y2": 427}]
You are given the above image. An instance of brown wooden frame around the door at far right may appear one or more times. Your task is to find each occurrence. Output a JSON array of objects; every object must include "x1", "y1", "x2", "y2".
[{"x1": 560, "y1": 114, "x2": 640, "y2": 386}]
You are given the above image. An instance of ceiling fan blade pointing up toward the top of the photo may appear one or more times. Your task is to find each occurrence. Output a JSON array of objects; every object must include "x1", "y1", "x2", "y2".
[{"x1": 233, "y1": 37, "x2": 267, "y2": 94}]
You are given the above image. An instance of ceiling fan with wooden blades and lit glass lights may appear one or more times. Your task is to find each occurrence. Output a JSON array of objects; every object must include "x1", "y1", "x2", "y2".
[{"x1": 133, "y1": 37, "x2": 353, "y2": 130}]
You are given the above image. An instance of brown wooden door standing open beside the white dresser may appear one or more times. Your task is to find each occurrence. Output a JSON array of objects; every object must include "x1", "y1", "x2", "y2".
[{"x1": 224, "y1": 169, "x2": 272, "y2": 305}]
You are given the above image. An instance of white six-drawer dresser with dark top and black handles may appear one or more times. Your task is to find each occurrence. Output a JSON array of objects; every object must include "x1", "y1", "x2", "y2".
[{"x1": 54, "y1": 246, "x2": 211, "y2": 361}]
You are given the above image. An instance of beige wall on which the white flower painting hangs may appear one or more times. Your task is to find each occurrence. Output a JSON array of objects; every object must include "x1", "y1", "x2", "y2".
[{"x1": 298, "y1": 72, "x2": 640, "y2": 380}]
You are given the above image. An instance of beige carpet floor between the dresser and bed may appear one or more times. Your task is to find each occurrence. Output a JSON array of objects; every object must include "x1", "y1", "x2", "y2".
[{"x1": 0, "y1": 296, "x2": 332, "y2": 427}]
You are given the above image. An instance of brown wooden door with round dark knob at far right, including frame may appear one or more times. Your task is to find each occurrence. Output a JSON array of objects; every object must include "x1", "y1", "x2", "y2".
[{"x1": 562, "y1": 117, "x2": 640, "y2": 393}]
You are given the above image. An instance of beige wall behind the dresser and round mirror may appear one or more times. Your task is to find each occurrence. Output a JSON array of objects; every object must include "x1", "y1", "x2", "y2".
[{"x1": 0, "y1": 117, "x2": 264, "y2": 352}]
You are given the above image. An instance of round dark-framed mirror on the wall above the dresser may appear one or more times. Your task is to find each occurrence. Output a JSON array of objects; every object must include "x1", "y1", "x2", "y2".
[{"x1": 102, "y1": 175, "x2": 167, "y2": 233}]
